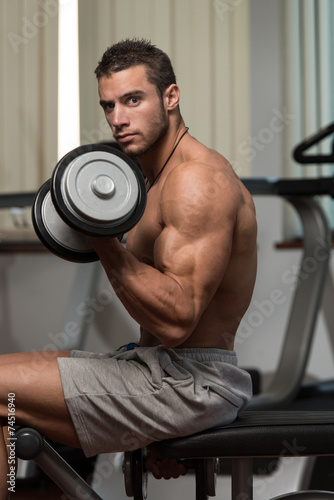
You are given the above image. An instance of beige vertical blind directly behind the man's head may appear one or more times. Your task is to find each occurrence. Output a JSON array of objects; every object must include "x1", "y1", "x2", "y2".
[{"x1": 79, "y1": 0, "x2": 250, "y2": 176}]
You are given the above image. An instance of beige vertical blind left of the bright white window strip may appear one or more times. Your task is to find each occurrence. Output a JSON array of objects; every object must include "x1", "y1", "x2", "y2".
[{"x1": 0, "y1": 0, "x2": 58, "y2": 229}]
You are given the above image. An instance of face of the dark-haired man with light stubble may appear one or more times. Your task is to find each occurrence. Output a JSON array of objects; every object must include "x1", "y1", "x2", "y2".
[{"x1": 98, "y1": 65, "x2": 169, "y2": 156}]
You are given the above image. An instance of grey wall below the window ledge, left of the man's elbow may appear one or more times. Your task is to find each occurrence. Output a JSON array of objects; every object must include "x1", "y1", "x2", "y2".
[{"x1": 0, "y1": 252, "x2": 138, "y2": 353}]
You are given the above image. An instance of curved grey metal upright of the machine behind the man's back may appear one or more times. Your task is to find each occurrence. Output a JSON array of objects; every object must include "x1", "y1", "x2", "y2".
[{"x1": 249, "y1": 198, "x2": 331, "y2": 410}]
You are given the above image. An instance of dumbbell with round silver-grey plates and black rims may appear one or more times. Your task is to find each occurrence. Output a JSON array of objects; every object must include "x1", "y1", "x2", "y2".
[{"x1": 32, "y1": 144, "x2": 146, "y2": 262}]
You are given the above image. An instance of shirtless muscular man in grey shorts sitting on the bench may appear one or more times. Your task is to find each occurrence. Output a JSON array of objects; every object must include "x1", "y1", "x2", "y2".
[{"x1": 0, "y1": 40, "x2": 257, "y2": 499}]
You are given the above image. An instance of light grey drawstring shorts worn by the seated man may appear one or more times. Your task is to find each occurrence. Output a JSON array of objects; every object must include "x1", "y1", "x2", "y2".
[{"x1": 58, "y1": 346, "x2": 252, "y2": 457}]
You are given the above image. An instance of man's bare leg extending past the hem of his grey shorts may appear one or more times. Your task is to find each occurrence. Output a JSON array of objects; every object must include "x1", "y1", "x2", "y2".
[{"x1": 0, "y1": 352, "x2": 80, "y2": 500}]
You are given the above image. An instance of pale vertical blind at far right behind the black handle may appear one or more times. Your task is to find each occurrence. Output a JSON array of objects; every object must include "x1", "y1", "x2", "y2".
[{"x1": 282, "y1": 0, "x2": 334, "y2": 238}]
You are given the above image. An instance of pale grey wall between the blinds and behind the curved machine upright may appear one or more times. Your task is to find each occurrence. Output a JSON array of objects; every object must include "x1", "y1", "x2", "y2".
[{"x1": 236, "y1": 0, "x2": 334, "y2": 378}]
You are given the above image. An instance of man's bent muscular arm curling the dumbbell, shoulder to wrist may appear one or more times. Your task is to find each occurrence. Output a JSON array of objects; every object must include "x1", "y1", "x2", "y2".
[{"x1": 88, "y1": 164, "x2": 238, "y2": 347}]
